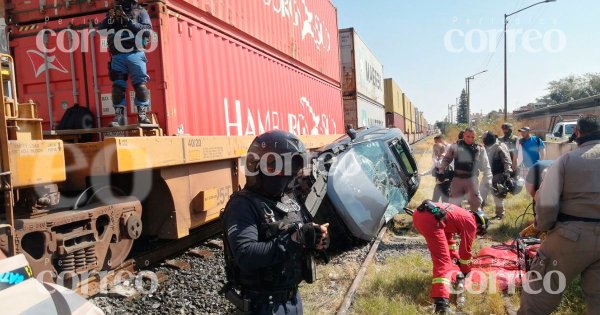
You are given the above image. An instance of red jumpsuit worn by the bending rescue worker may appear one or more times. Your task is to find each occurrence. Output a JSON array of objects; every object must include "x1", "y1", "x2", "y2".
[{"x1": 413, "y1": 202, "x2": 477, "y2": 298}]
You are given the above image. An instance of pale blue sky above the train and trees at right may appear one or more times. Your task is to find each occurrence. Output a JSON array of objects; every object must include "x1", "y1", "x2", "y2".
[{"x1": 333, "y1": 0, "x2": 600, "y2": 122}]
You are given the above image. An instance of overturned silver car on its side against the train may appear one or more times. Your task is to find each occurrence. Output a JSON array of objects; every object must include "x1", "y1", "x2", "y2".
[{"x1": 304, "y1": 127, "x2": 419, "y2": 247}]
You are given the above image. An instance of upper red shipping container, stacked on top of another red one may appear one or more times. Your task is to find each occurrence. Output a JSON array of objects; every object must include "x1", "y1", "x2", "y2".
[{"x1": 9, "y1": 0, "x2": 340, "y2": 85}]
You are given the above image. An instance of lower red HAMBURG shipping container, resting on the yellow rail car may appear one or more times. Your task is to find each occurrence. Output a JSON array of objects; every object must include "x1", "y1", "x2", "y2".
[{"x1": 11, "y1": 4, "x2": 343, "y2": 135}]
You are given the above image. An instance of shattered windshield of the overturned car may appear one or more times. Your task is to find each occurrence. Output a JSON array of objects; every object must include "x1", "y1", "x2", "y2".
[{"x1": 352, "y1": 141, "x2": 408, "y2": 222}]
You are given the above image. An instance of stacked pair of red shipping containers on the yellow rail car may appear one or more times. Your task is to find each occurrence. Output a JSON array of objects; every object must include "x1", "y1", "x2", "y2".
[{"x1": 7, "y1": 0, "x2": 342, "y2": 136}]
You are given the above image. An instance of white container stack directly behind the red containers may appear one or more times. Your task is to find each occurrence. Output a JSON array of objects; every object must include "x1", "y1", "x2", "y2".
[{"x1": 339, "y1": 28, "x2": 386, "y2": 128}]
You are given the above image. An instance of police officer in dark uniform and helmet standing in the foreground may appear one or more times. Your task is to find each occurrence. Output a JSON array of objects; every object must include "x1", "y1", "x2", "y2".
[{"x1": 222, "y1": 130, "x2": 328, "y2": 314}]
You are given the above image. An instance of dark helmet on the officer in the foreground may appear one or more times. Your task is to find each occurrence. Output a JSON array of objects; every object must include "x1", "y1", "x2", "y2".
[{"x1": 246, "y1": 130, "x2": 305, "y2": 186}]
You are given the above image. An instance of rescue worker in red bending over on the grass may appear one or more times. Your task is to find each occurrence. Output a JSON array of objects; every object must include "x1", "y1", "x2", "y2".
[{"x1": 413, "y1": 200, "x2": 488, "y2": 314}]
